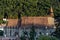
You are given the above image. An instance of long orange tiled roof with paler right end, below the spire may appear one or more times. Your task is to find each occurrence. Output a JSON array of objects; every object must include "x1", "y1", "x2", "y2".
[{"x1": 22, "y1": 17, "x2": 54, "y2": 26}]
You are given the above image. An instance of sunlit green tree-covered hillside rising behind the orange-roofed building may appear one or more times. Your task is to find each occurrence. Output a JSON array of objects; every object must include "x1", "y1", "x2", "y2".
[{"x1": 0, "y1": 0, "x2": 60, "y2": 18}]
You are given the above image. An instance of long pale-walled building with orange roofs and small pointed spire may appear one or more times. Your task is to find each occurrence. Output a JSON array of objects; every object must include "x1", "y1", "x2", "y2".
[{"x1": 0, "y1": 7, "x2": 56, "y2": 40}]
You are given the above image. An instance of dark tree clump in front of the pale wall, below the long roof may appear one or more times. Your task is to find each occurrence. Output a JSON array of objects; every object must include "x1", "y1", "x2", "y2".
[{"x1": 20, "y1": 25, "x2": 36, "y2": 40}]
